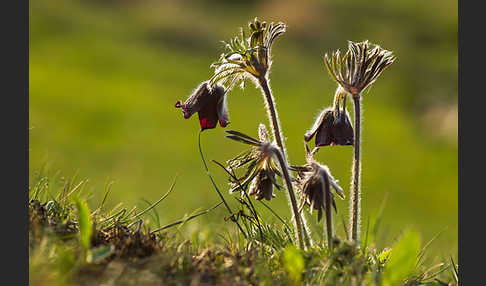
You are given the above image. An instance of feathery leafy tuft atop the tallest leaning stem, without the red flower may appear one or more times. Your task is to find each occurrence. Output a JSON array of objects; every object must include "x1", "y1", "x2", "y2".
[{"x1": 210, "y1": 18, "x2": 286, "y2": 89}]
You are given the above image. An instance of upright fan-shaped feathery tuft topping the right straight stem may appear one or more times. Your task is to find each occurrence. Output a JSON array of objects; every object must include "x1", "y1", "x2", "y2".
[{"x1": 324, "y1": 41, "x2": 395, "y2": 97}]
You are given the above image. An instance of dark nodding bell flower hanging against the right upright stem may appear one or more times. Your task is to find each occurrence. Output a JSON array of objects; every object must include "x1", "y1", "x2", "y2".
[{"x1": 304, "y1": 88, "x2": 354, "y2": 147}]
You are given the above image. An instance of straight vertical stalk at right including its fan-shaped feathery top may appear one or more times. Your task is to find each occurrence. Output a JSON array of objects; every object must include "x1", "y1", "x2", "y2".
[{"x1": 324, "y1": 41, "x2": 395, "y2": 246}]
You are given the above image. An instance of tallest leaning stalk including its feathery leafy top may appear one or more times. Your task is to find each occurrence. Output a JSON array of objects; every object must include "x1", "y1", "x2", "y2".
[{"x1": 209, "y1": 18, "x2": 309, "y2": 247}]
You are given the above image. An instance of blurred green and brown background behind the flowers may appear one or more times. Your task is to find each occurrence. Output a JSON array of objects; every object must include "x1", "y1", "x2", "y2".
[{"x1": 29, "y1": 0, "x2": 458, "y2": 256}]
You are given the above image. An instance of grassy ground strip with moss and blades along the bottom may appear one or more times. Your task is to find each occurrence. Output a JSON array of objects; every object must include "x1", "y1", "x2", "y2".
[{"x1": 28, "y1": 174, "x2": 457, "y2": 286}]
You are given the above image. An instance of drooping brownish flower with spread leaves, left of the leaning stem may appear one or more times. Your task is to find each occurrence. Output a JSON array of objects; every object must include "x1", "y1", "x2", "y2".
[{"x1": 226, "y1": 124, "x2": 281, "y2": 201}]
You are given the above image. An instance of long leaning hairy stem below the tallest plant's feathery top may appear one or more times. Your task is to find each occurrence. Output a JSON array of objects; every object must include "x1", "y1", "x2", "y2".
[{"x1": 258, "y1": 76, "x2": 310, "y2": 248}]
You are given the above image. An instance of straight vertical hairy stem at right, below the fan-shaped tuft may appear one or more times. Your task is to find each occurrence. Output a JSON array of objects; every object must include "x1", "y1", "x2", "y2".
[{"x1": 350, "y1": 94, "x2": 361, "y2": 246}]
